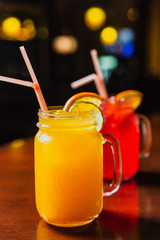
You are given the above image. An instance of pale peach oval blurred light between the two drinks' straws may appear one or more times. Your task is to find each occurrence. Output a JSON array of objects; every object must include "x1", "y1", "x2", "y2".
[{"x1": 52, "y1": 35, "x2": 78, "y2": 55}]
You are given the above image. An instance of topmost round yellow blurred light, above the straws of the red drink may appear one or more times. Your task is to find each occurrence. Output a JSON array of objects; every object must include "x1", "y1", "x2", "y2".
[{"x1": 84, "y1": 7, "x2": 107, "y2": 30}]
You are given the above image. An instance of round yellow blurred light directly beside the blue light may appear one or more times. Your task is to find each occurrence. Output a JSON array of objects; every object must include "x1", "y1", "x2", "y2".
[{"x1": 100, "y1": 27, "x2": 118, "y2": 45}]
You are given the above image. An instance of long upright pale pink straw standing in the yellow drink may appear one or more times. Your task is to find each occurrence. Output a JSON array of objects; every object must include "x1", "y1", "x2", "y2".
[{"x1": 20, "y1": 46, "x2": 48, "y2": 111}]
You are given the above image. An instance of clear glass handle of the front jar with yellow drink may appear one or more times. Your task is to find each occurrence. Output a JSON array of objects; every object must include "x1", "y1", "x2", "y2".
[{"x1": 103, "y1": 134, "x2": 122, "y2": 196}]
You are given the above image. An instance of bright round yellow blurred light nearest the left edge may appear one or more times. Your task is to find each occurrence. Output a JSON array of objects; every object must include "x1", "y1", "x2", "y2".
[{"x1": 2, "y1": 17, "x2": 21, "y2": 38}]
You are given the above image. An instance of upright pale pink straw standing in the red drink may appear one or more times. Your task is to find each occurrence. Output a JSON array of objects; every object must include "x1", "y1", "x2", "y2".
[{"x1": 90, "y1": 49, "x2": 108, "y2": 98}]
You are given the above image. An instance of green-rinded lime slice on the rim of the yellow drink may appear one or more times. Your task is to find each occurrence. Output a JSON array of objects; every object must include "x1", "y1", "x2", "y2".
[{"x1": 68, "y1": 101, "x2": 104, "y2": 132}]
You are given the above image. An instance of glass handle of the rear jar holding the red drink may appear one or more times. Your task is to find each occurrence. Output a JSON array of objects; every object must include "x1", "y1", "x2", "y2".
[{"x1": 137, "y1": 114, "x2": 152, "y2": 159}]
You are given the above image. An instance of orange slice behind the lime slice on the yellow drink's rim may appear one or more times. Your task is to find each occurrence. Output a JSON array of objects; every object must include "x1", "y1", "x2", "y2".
[{"x1": 63, "y1": 92, "x2": 103, "y2": 111}]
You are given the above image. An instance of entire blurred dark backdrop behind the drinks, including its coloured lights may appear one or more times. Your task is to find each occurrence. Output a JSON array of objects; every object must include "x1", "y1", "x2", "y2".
[{"x1": 0, "y1": 0, "x2": 160, "y2": 144}]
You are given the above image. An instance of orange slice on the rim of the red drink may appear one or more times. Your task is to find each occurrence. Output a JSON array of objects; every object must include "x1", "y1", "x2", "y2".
[{"x1": 116, "y1": 90, "x2": 143, "y2": 110}]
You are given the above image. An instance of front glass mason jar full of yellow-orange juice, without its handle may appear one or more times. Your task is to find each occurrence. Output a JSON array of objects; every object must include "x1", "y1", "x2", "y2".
[{"x1": 35, "y1": 106, "x2": 119, "y2": 227}]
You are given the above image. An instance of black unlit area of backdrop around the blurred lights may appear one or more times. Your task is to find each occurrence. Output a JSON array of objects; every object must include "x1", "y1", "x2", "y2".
[{"x1": 0, "y1": 0, "x2": 160, "y2": 144}]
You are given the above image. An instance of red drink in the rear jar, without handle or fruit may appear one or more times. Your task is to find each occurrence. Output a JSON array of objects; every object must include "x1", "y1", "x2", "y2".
[{"x1": 100, "y1": 97, "x2": 140, "y2": 180}]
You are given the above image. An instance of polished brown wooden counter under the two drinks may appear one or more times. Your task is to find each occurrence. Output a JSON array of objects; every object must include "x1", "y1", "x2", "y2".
[{"x1": 0, "y1": 114, "x2": 160, "y2": 240}]
